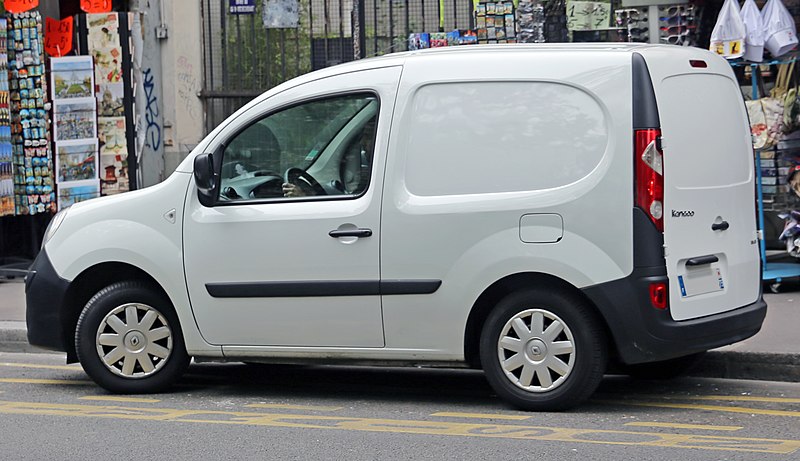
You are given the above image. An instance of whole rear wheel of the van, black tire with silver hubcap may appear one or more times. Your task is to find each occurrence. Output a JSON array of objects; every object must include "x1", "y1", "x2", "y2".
[{"x1": 480, "y1": 288, "x2": 608, "y2": 411}]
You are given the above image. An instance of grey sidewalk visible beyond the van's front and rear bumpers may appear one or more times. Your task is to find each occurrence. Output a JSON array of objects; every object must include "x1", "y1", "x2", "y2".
[{"x1": 0, "y1": 278, "x2": 800, "y2": 382}]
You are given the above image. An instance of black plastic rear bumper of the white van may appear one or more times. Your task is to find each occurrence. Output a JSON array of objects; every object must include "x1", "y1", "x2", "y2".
[{"x1": 583, "y1": 266, "x2": 767, "y2": 364}]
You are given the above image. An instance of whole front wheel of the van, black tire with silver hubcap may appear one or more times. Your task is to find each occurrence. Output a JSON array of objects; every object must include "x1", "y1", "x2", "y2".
[{"x1": 75, "y1": 282, "x2": 189, "y2": 394}]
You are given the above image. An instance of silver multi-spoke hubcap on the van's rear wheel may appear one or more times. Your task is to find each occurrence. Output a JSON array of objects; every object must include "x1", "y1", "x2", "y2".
[{"x1": 497, "y1": 309, "x2": 575, "y2": 392}]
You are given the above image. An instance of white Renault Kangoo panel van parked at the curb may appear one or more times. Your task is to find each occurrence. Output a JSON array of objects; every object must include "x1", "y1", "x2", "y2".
[{"x1": 27, "y1": 44, "x2": 766, "y2": 410}]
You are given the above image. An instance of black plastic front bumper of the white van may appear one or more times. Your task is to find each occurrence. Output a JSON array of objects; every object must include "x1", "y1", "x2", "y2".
[{"x1": 25, "y1": 249, "x2": 72, "y2": 352}]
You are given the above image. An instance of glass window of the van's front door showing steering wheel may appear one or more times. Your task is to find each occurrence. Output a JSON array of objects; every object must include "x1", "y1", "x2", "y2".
[{"x1": 220, "y1": 94, "x2": 379, "y2": 202}]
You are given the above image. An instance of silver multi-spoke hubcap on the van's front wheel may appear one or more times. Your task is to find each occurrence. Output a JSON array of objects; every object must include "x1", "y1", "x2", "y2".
[{"x1": 95, "y1": 303, "x2": 172, "y2": 378}]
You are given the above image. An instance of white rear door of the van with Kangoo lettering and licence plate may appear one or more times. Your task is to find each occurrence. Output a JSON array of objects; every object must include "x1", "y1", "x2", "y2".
[{"x1": 641, "y1": 46, "x2": 761, "y2": 320}]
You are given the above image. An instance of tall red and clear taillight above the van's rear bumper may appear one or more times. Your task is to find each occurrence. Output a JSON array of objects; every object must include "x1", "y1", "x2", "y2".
[{"x1": 633, "y1": 129, "x2": 664, "y2": 232}]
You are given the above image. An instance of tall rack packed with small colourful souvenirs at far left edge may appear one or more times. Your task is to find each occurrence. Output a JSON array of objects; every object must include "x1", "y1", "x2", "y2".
[{"x1": 0, "y1": 11, "x2": 55, "y2": 277}]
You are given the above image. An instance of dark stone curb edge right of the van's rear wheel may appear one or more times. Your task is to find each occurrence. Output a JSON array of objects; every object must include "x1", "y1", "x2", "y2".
[{"x1": 688, "y1": 351, "x2": 800, "y2": 383}]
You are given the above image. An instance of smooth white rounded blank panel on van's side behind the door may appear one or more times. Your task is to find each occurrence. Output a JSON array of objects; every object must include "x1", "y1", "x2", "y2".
[{"x1": 405, "y1": 82, "x2": 608, "y2": 196}]
